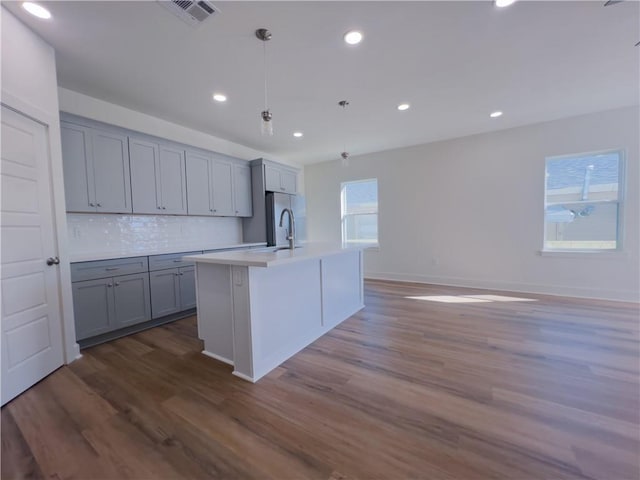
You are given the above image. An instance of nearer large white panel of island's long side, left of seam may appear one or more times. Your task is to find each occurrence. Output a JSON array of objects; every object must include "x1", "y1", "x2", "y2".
[{"x1": 249, "y1": 259, "x2": 325, "y2": 381}]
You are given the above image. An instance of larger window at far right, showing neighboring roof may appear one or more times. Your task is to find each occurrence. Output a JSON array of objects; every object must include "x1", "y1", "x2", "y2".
[{"x1": 544, "y1": 151, "x2": 623, "y2": 251}]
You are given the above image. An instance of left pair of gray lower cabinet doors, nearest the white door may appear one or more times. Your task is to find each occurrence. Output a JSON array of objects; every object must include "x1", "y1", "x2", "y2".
[{"x1": 72, "y1": 273, "x2": 151, "y2": 340}]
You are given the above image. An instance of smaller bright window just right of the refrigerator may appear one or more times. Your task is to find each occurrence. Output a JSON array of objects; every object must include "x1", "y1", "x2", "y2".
[{"x1": 340, "y1": 178, "x2": 378, "y2": 246}]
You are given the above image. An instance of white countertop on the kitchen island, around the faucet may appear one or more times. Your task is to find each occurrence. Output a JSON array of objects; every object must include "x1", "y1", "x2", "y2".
[{"x1": 184, "y1": 243, "x2": 362, "y2": 267}]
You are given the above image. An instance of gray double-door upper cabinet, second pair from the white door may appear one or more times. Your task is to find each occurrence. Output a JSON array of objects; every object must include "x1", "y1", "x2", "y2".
[{"x1": 129, "y1": 137, "x2": 187, "y2": 215}]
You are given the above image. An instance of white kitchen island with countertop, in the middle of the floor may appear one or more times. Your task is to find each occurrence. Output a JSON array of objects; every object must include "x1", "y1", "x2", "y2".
[{"x1": 185, "y1": 244, "x2": 364, "y2": 382}]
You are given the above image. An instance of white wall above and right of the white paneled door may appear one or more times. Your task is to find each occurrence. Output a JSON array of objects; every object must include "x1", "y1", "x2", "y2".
[{"x1": 0, "y1": 7, "x2": 80, "y2": 363}]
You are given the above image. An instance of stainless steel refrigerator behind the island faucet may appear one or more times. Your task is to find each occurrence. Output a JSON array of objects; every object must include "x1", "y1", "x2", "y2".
[{"x1": 265, "y1": 192, "x2": 307, "y2": 247}]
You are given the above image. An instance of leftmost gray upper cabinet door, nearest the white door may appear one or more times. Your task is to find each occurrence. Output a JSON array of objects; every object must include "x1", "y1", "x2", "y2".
[{"x1": 60, "y1": 122, "x2": 96, "y2": 212}]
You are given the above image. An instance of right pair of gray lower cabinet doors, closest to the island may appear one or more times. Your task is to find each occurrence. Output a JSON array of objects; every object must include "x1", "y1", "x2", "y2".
[{"x1": 149, "y1": 266, "x2": 196, "y2": 318}]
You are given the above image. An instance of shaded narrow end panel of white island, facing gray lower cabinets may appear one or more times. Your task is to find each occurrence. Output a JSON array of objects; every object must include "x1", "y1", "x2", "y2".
[{"x1": 196, "y1": 262, "x2": 233, "y2": 364}]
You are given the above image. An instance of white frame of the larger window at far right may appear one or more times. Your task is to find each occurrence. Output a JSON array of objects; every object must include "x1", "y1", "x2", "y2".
[{"x1": 540, "y1": 148, "x2": 627, "y2": 256}]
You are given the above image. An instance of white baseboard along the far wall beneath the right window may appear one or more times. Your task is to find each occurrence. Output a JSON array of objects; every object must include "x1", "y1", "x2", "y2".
[{"x1": 365, "y1": 272, "x2": 640, "y2": 303}]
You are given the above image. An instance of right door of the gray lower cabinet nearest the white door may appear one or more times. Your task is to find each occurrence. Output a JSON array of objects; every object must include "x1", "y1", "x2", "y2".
[{"x1": 113, "y1": 273, "x2": 151, "y2": 328}]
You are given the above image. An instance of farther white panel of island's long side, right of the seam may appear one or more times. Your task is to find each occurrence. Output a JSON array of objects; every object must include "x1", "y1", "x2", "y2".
[{"x1": 321, "y1": 250, "x2": 364, "y2": 331}]
